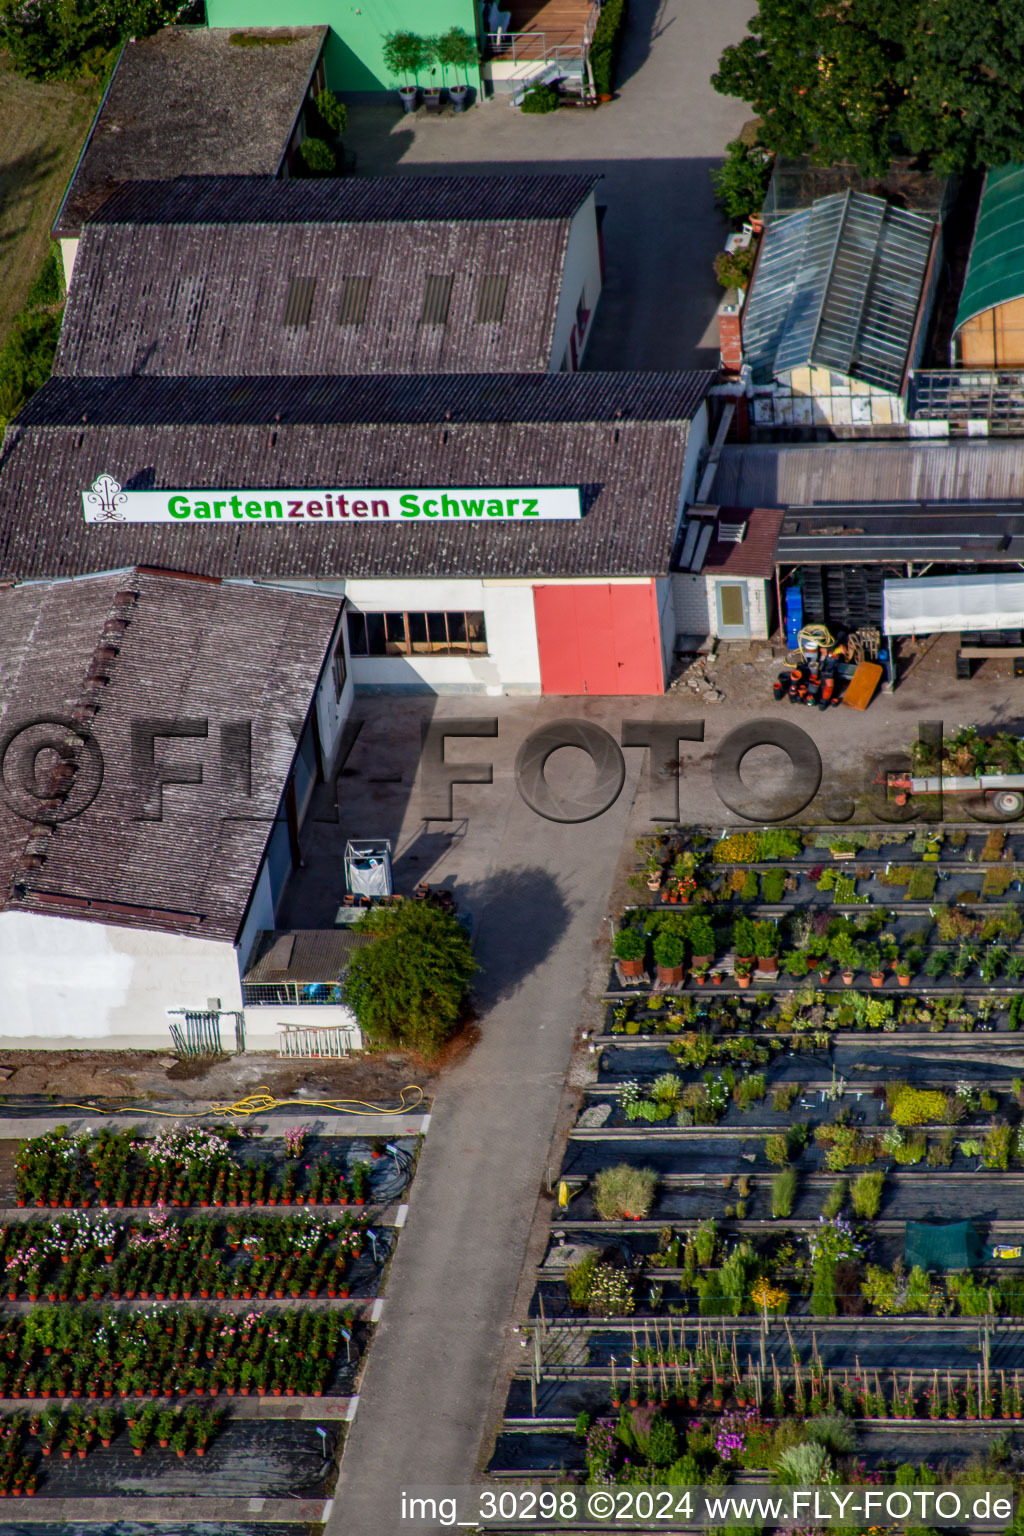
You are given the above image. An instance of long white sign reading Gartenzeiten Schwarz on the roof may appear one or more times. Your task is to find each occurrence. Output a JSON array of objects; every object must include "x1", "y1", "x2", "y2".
[{"x1": 81, "y1": 475, "x2": 580, "y2": 527}]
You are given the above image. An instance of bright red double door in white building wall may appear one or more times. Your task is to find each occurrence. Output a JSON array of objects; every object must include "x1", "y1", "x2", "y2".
[{"x1": 533, "y1": 581, "x2": 665, "y2": 694}]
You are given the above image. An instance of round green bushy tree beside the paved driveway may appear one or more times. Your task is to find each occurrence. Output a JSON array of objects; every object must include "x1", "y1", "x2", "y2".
[{"x1": 342, "y1": 902, "x2": 476, "y2": 1057}]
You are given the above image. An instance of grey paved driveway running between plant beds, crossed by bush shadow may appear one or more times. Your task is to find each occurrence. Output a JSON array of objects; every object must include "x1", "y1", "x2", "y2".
[{"x1": 329, "y1": 700, "x2": 636, "y2": 1536}]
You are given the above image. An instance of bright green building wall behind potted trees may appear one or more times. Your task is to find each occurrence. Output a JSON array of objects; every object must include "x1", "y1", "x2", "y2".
[{"x1": 206, "y1": 0, "x2": 481, "y2": 94}]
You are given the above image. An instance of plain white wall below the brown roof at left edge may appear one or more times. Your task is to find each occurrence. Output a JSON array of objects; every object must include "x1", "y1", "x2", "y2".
[{"x1": 0, "y1": 912, "x2": 241, "y2": 1051}]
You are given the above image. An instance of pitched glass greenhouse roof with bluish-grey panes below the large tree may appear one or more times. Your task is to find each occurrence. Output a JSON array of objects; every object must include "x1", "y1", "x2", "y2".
[{"x1": 743, "y1": 192, "x2": 935, "y2": 392}]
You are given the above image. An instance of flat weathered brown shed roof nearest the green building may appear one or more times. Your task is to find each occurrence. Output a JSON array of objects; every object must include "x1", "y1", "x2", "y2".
[{"x1": 54, "y1": 26, "x2": 327, "y2": 238}]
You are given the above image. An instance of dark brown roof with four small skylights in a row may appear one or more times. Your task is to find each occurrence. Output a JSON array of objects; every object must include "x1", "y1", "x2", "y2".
[{"x1": 55, "y1": 175, "x2": 597, "y2": 376}]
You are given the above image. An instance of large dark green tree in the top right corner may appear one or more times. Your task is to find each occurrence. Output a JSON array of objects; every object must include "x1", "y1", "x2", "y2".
[{"x1": 712, "y1": 0, "x2": 1024, "y2": 175}]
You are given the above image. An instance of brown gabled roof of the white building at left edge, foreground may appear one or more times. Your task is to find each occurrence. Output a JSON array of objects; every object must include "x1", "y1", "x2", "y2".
[{"x1": 0, "y1": 571, "x2": 338, "y2": 942}]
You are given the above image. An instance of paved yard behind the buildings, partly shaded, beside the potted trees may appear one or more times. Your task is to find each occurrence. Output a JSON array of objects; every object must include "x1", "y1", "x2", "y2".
[{"x1": 345, "y1": 0, "x2": 755, "y2": 370}]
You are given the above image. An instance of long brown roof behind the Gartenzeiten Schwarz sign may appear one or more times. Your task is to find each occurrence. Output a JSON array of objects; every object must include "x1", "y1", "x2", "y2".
[{"x1": 0, "y1": 373, "x2": 714, "y2": 578}]
